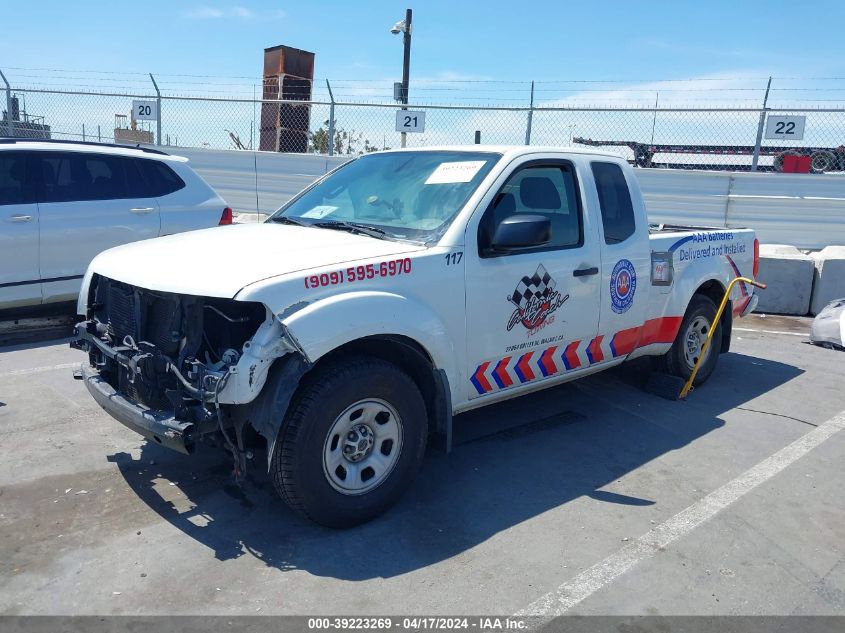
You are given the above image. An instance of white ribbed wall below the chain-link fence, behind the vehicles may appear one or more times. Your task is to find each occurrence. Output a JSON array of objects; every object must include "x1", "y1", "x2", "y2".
[{"x1": 173, "y1": 148, "x2": 845, "y2": 249}]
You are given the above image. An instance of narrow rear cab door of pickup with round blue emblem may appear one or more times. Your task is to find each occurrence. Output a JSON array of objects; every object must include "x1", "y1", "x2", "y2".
[{"x1": 585, "y1": 159, "x2": 651, "y2": 350}]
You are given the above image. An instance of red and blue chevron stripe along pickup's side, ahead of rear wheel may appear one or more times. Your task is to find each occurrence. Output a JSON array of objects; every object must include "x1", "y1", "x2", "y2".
[{"x1": 470, "y1": 316, "x2": 682, "y2": 396}]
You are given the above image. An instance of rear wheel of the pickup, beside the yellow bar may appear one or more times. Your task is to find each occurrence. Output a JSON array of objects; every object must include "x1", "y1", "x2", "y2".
[{"x1": 657, "y1": 294, "x2": 722, "y2": 387}]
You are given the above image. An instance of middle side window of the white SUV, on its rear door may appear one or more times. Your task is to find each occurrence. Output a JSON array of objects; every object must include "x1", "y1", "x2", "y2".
[{"x1": 39, "y1": 152, "x2": 129, "y2": 202}]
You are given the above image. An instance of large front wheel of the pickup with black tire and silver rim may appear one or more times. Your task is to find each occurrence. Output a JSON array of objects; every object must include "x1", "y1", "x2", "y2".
[{"x1": 270, "y1": 357, "x2": 428, "y2": 528}]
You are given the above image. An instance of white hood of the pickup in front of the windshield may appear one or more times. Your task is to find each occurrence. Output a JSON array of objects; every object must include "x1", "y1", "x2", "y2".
[{"x1": 83, "y1": 222, "x2": 425, "y2": 298}]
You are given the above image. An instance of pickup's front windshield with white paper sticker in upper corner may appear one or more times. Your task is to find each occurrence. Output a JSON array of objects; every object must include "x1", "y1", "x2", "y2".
[{"x1": 269, "y1": 151, "x2": 501, "y2": 242}]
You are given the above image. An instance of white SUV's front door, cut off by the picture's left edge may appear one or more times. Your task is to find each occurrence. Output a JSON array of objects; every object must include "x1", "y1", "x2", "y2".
[{"x1": 0, "y1": 151, "x2": 41, "y2": 309}]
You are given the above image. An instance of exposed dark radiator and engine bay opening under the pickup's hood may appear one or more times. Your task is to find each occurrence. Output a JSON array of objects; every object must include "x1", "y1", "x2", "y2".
[{"x1": 77, "y1": 277, "x2": 268, "y2": 413}]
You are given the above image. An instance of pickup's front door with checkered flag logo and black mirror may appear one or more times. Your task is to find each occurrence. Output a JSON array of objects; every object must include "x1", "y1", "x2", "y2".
[{"x1": 465, "y1": 158, "x2": 602, "y2": 400}]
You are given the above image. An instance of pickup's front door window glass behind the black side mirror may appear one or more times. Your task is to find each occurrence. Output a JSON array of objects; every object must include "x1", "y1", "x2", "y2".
[{"x1": 478, "y1": 164, "x2": 584, "y2": 256}]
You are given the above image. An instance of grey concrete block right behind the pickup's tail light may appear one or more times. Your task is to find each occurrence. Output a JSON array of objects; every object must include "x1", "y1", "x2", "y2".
[{"x1": 755, "y1": 244, "x2": 815, "y2": 315}]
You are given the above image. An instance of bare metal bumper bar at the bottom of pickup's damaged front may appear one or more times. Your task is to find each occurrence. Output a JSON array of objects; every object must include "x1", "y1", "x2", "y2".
[{"x1": 82, "y1": 363, "x2": 195, "y2": 455}]
